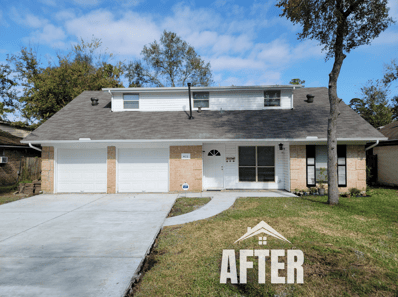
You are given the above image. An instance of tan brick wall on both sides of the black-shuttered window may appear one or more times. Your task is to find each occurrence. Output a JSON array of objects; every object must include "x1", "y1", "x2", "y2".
[{"x1": 290, "y1": 145, "x2": 366, "y2": 192}]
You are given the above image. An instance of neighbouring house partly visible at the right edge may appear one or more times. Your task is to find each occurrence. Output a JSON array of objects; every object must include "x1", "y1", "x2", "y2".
[{"x1": 369, "y1": 121, "x2": 398, "y2": 186}]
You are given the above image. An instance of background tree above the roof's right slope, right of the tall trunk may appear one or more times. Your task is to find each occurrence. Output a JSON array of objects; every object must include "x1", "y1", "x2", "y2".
[{"x1": 349, "y1": 80, "x2": 393, "y2": 128}]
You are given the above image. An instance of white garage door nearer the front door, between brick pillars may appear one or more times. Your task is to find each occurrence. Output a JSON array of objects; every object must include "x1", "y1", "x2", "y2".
[{"x1": 118, "y1": 148, "x2": 169, "y2": 192}]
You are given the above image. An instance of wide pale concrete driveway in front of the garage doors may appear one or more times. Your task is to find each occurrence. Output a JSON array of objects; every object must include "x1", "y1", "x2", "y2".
[{"x1": 0, "y1": 194, "x2": 177, "y2": 297}]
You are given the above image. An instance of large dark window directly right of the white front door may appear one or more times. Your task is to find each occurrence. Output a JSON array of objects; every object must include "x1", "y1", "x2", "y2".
[{"x1": 239, "y1": 146, "x2": 275, "y2": 182}]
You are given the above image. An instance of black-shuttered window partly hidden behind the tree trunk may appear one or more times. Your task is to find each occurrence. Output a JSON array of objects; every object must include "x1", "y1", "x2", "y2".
[{"x1": 306, "y1": 145, "x2": 347, "y2": 187}]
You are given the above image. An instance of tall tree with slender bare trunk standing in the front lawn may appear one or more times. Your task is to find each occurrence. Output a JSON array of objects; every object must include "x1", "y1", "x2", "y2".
[{"x1": 277, "y1": 0, "x2": 394, "y2": 204}]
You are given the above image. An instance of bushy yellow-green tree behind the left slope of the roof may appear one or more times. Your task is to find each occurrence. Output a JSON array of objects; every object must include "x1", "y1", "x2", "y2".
[{"x1": 9, "y1": 39, "x2": 123, "y2": 127}]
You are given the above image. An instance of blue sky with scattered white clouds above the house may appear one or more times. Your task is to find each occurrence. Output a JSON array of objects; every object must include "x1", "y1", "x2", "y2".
[{"x1": 0, "y1": 0, "x2": 398, "y2": 103}]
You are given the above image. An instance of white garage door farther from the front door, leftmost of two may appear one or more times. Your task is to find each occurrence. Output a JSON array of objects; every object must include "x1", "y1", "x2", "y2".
[{"x1": 57, "y1": 149, "x2": 107, "y2": 193}]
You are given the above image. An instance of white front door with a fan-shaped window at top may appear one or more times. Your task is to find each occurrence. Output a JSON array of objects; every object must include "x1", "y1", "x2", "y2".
[{"x1": 203, "y1": 144, "x2": 225, "y2": 189}]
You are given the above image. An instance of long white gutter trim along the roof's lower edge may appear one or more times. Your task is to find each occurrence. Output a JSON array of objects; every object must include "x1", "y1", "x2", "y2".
[{"x1": 21, "y1": 137, "x2": 388, "y2": 144}]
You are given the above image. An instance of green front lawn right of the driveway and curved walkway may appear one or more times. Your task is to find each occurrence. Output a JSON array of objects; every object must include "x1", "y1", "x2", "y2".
[{"x1": 134, "y1": 189, "x2": 398, "y2": 297}]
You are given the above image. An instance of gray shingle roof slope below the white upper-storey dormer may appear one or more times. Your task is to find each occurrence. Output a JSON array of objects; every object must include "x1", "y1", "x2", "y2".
[{"x1": 24, "y1": 88, "x2": 384, "y2": 142}]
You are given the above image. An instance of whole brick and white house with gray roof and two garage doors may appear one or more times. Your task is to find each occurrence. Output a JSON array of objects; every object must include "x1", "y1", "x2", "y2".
[{"x1": 23, "y1": 85, "x2": 386, "y2": 193}]
